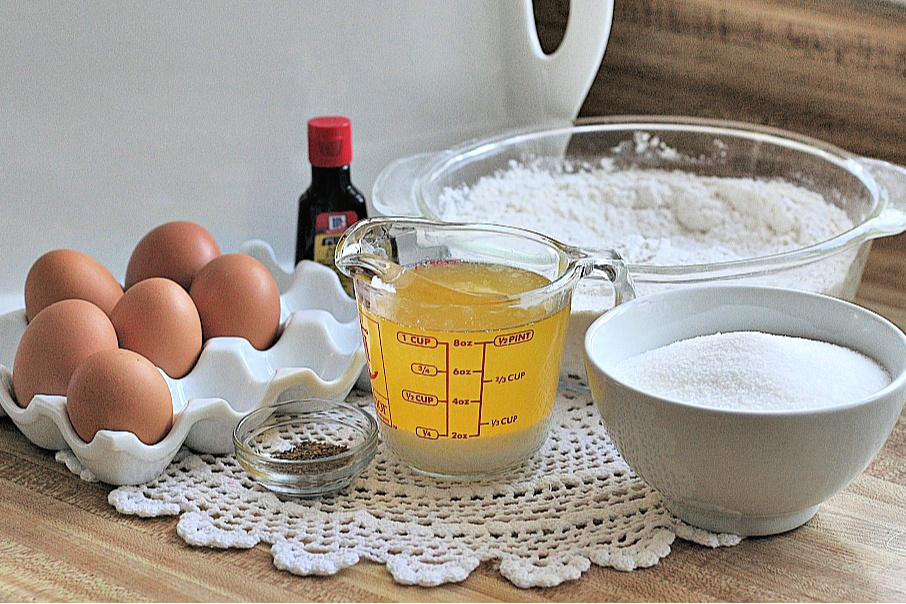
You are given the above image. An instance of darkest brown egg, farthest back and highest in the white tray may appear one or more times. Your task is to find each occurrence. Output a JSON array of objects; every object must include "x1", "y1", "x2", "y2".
[{"x1": 126, "y1": 221, "x2": 220, "y2": 291}]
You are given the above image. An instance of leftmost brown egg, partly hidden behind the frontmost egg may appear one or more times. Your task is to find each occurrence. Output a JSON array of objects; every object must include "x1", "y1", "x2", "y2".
[{"x1": 13, "y1": 299, "x2": 117, "y2": 407}]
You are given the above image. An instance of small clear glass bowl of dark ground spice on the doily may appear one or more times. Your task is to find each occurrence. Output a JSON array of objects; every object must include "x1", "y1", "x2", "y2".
[{"x1": 233, "y1": 399, "x2": 378, "y2": 497}]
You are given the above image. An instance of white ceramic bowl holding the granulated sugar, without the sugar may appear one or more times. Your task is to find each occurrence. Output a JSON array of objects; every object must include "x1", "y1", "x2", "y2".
[{"x1": 585, "y1": 285, "x2": 906, "y2": 535}]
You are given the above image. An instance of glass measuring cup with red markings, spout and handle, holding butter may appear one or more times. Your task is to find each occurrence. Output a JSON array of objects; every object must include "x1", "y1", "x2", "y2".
[{"x1": 336, "y1": 218, "x2": 635, "y2": 479}]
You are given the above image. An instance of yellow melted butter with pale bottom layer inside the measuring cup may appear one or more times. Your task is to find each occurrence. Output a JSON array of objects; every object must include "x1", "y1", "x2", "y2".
[{"x1": 359, "y1": 260, "x2": 569, "y2": 477}]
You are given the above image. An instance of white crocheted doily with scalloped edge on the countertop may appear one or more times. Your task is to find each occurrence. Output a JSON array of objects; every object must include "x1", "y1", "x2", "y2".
[{"x1": 58, "y1": 390, "x2": 740, "y2": 587}]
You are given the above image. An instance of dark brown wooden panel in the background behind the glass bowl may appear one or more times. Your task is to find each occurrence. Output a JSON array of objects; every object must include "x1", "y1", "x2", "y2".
[{"x1": 535, "y1": 0, "x2": 906, "y2": 164}]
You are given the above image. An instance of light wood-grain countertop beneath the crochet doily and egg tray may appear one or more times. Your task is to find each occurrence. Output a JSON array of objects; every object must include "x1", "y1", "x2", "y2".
[{"x1": 0, "y1": 237, "x2": 906, "y2": 602}]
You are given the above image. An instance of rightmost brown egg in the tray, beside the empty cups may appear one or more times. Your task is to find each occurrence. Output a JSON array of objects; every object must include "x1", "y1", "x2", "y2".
[{"x1": 189, "y1": 254, "x2": 280, "y2": 350}]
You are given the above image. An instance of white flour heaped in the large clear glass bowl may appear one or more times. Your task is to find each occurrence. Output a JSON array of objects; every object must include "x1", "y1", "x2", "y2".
[{"x1": 435, "y1": 159, "x2": 855, "y2": 377}]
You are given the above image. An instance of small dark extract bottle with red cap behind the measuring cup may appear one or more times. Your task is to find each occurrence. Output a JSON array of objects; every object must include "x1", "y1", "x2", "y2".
[{"x1": 296, "y1": 116, "x2": 367, "y2": 295}]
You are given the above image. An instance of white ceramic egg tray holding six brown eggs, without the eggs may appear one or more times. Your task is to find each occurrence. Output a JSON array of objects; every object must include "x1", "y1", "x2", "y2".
[{"x1": 0, "y1": 241, "x2": 367, "y2": 485}]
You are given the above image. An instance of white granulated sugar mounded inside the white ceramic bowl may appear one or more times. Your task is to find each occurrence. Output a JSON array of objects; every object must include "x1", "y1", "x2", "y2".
[{"x1": 612, "y1": 331, "x2": 890, "y2": 411}]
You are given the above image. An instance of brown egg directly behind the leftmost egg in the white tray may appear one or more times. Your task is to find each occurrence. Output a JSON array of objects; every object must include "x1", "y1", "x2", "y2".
[{"x1": 25, "y1": 250, "x2": 123, "y2": 321}]
